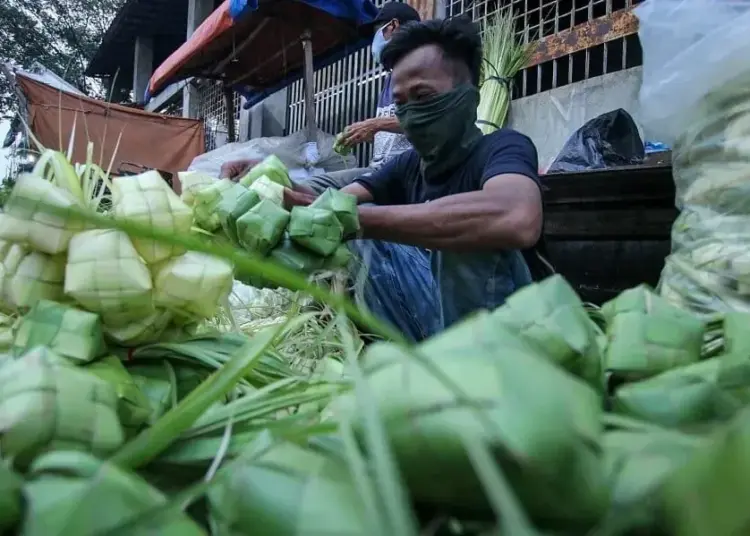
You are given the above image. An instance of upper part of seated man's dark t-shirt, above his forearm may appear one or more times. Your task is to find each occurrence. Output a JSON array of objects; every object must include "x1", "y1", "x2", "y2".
[{"x1": 355, "y1": 128, "x2": 539, "y2": 205}]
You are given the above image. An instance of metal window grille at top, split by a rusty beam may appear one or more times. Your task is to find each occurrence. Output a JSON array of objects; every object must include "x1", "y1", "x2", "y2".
[{"x1": 447, "y1": 0, "x2": 643, "y2": 98}]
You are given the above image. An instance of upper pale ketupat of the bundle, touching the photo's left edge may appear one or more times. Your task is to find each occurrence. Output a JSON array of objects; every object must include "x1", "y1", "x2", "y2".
[{"x1": 0, "y1": 174, "x2": 83, "y2": 255}]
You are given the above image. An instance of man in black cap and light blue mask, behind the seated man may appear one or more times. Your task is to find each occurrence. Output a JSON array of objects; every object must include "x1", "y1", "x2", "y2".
[{"x1": 222, "y1": 2, "x2": 420, "y2": 193}]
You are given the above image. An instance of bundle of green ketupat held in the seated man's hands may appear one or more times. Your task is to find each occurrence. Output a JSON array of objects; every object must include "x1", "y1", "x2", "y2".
[{"x1": 180, "y1": 155, "x2": 359, "y2": 288}]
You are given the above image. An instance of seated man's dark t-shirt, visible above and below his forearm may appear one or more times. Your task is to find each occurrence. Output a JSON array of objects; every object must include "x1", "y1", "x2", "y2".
[{"x1": 356, "y1": 129, "x2": 539, "y2": 327}]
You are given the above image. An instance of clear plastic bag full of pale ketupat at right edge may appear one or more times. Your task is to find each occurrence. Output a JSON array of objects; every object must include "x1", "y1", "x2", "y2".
[{"x1": 636, "y1": 0, "x2": 750, "y2": 314}]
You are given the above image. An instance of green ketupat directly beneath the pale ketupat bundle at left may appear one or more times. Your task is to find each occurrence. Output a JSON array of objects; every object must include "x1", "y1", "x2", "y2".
[{"x1": 13, "y1": 300, "x2": 105, "y2": 364}]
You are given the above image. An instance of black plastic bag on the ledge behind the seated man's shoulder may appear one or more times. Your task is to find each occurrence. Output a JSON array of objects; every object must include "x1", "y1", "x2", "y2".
[{"x1": 547, "y1": 108, "x2": 645, "y2": 173}]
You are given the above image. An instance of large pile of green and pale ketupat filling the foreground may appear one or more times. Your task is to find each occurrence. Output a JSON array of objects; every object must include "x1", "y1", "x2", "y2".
[{"x1": 0, "y1": 148, "x2": 750, "y2": 536}]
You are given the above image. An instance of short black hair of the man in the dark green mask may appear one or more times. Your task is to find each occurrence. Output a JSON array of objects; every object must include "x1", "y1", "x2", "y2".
[{"x1": 381, "y1": 15, "x2": 482, "y2": 86}]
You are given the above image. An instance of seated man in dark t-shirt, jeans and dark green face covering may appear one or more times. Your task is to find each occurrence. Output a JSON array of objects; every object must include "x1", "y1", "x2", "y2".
[{"x1": 286, "y1": 18, "x2": 542, "y2": 340}]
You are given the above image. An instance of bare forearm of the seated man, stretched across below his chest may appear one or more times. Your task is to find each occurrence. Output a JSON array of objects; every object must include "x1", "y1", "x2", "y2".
[{"x1": 359, "y1": 192, "x2": 536, "y2": 251}]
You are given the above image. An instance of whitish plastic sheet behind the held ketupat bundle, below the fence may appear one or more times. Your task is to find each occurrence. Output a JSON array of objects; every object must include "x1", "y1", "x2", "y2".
[{"x1": 188, "y1": 130, "x2": 357, "y2": 180}]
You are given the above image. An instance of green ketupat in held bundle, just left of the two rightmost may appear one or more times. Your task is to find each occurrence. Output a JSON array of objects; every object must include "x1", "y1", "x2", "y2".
[{"x1": 237, "y1": 199, "x2": 289, "y2": 255}]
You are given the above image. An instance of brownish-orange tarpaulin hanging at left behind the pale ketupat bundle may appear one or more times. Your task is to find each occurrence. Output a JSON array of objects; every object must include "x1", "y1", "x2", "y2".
[{"x1": 16, "y1": 74, "x2": 205, "y2": 174}]
